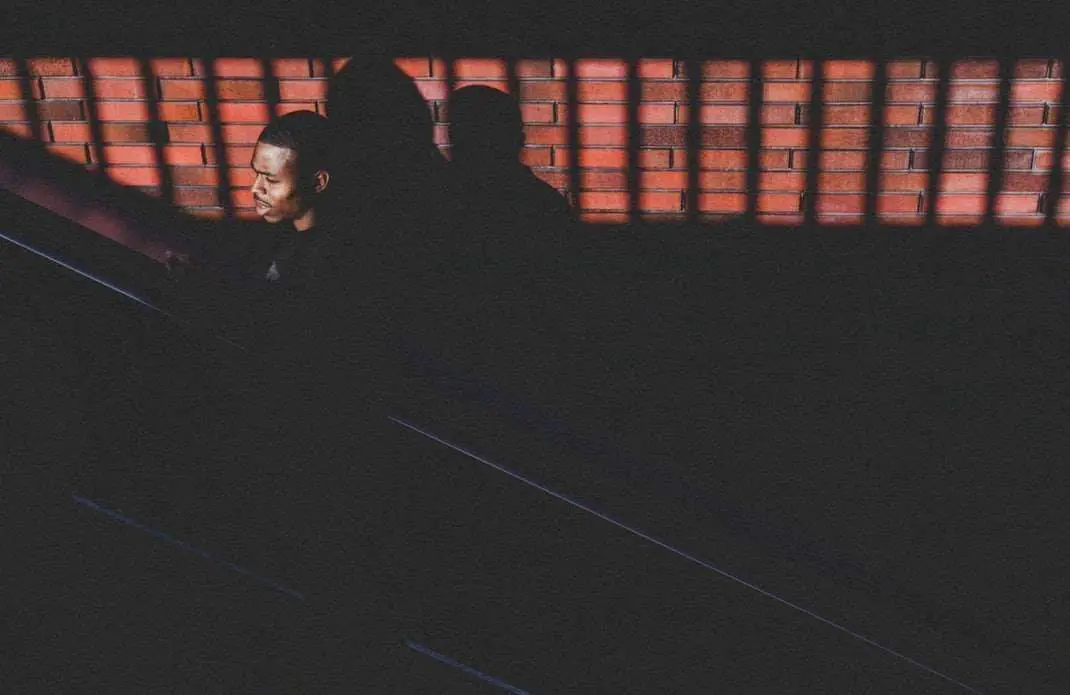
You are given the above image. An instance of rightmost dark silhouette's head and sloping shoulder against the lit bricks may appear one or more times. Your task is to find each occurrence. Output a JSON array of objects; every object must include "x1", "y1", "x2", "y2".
[{"x1": 448, "y1": 86, "x2": 570, "y2": 231}]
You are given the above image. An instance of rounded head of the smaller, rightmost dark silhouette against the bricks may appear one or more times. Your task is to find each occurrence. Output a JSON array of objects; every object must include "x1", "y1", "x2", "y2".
[{"x1": 449, "y1": 86, "x2": 524, "y2": 163}]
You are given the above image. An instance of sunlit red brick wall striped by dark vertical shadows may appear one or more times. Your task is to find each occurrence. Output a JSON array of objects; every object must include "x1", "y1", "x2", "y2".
[{"x1": 0, "y1": 57, "x2": 1070, "y2": 226}]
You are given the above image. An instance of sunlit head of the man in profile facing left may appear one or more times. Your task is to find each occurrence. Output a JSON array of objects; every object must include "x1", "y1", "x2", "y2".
[{"x1": 250, "y1": 111, "x2": 331, "y2": 231}]
